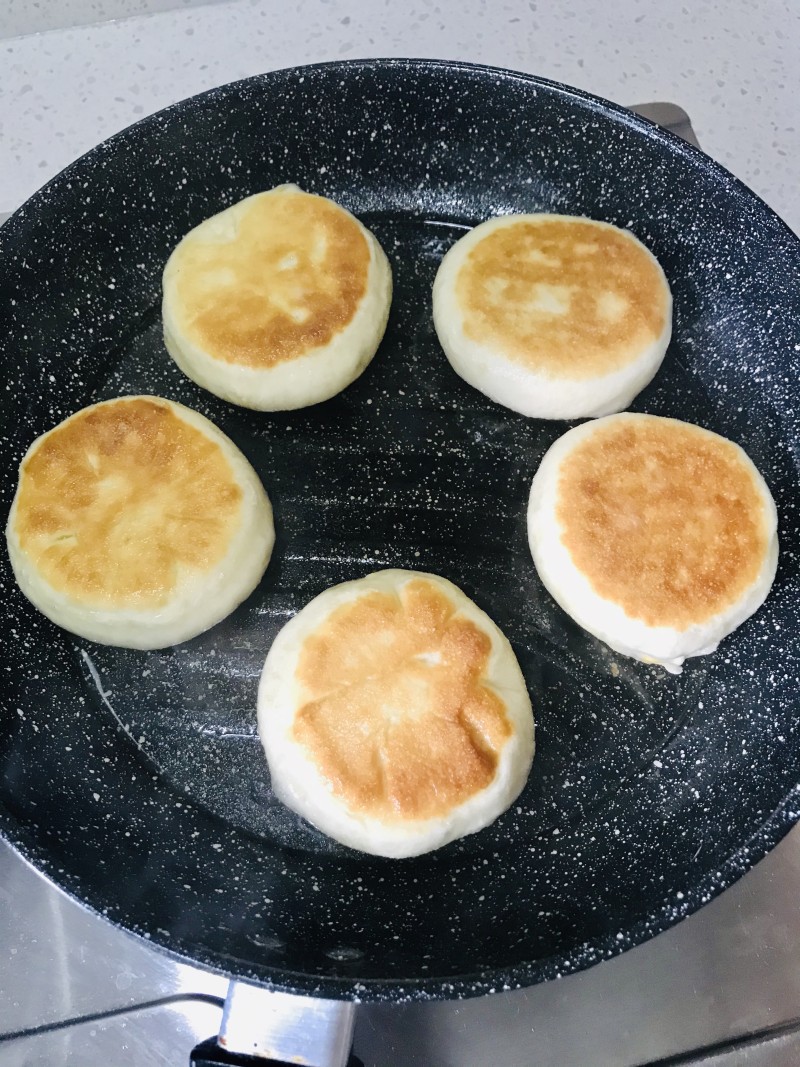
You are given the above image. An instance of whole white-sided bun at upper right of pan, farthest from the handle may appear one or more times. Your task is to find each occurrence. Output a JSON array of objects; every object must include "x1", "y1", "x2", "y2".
[{"x1": 433, "y1": 214, "x2": 672, "y2": 418}]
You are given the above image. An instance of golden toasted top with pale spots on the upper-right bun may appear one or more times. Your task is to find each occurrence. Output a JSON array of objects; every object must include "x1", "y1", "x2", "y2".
[{"x1": 455, "y1": 218, "x2": 667, "y2": 380}]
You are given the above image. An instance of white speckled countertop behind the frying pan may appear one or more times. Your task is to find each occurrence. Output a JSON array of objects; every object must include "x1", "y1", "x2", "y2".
[{"x1": 0, "y1": 0, "x2": 800, "y2": 233}]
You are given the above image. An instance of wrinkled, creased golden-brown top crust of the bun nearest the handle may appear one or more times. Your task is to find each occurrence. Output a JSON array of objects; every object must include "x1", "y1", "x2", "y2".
[{"x1": 292, "y1": 578, "x2": 511, "y2": 822}]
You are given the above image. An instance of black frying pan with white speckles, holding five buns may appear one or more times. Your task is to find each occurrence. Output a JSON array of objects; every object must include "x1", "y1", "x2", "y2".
[{"x1": 0, "y1": 61, "x2": 800, "y2": 999}]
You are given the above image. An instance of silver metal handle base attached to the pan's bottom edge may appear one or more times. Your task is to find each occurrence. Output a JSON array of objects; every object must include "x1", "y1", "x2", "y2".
[{"x1": 191, "y1": 981, "x2": 361, "y2": 1067}]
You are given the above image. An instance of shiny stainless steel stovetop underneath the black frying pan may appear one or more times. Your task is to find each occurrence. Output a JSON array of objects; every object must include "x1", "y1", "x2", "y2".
[{"x1": 0, "y1": 105, "x2": 800, "y2": 1067}]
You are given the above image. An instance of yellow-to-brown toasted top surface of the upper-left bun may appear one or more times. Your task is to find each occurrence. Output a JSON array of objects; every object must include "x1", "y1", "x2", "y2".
[{"x1": 175, "y1": 190, "x2": 370, "y2": 369}]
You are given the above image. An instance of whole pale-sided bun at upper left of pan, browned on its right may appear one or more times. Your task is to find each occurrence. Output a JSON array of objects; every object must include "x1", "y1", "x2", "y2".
[{"x1": 162, "y1": 186, "x2": 391, "y2": 411}]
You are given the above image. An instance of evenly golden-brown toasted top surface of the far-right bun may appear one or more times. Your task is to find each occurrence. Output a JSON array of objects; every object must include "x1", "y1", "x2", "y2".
[{"x1": 556, "y1": 419, "x2": 769, "y2": 631}]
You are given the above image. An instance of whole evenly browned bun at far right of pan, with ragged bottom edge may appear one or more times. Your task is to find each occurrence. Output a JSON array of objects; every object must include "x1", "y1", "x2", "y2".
[{"x1": 528, "y1": 413, "x2": 778, "y2": 673}]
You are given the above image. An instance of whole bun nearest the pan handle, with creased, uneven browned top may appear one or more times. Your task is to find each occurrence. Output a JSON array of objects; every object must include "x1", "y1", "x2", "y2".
[{"x1": 258, "y1": 570, "x2": 533, "y2": 857}]
